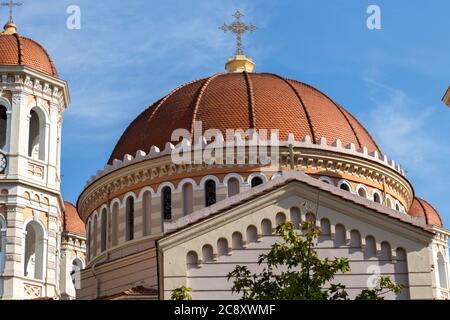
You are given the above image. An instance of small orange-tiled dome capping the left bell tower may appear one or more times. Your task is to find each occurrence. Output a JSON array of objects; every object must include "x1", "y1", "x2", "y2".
[{"x1": 0, "y1": 23, "x2": 58, "y2": 77}]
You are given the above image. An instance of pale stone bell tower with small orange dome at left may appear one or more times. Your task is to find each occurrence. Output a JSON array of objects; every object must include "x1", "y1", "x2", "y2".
[{"x1": 0, "y1": 14, "x2": 70, "y2": 299}]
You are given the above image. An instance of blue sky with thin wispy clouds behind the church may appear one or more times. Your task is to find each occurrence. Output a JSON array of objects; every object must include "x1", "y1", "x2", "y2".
[{"x1": 9, "y1": 0, "x2": 450, "y2": 227}]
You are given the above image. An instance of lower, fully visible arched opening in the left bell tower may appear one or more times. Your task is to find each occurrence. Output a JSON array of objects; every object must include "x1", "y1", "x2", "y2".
[{"x1": 24, "y1": 221, "x2": 45, "y2": 280}]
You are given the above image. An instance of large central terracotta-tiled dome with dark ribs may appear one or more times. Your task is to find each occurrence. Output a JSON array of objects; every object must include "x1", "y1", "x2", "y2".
[{"x1": 109, "y1": 72, "x2": 380, "y2": 163}]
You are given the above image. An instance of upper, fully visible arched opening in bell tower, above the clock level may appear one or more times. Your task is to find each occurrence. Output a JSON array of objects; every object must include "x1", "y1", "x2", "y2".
[{"x1": 28, "y1": 109, "x2": 45, "y2": 160}]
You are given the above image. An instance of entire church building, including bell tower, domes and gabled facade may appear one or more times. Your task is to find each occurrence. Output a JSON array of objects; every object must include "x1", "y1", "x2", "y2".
[{"x1": 0, "y1": 11, "x2": 450, "y2": 300}]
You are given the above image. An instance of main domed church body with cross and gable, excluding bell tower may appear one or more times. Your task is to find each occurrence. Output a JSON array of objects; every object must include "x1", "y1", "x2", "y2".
[{"x1": 77, "y1": 12, "x2": 450, "y2": 300}]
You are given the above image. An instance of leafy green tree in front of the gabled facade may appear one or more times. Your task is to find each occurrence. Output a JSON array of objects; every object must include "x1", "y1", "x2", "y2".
[{"x1": 228, "y1": 222, "x2": 403, "y2": 300}]
